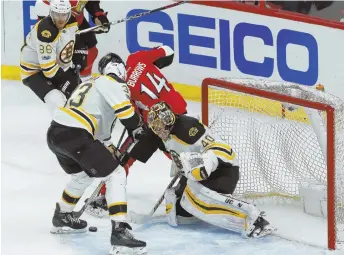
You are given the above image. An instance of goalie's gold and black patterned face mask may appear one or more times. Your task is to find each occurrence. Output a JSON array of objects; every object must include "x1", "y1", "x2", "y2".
[{"x1": 148, "y1": 102, "x2": 176, "y2": 141}]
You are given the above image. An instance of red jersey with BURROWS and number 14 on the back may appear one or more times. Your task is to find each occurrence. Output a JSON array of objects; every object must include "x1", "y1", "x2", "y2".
[{"x1": 126, "y1": 46, "x2": 187, "y2": 119}]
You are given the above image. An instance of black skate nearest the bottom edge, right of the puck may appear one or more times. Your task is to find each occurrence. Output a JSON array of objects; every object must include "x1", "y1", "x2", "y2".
[{"x1": 109, "y1": 221, "x2": 147, "y2": 255}]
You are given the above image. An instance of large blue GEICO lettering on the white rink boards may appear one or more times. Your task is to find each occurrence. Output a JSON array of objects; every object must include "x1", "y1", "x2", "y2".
[{"x1": 126, "y1": 9, "x2": 319, "y2": 85}]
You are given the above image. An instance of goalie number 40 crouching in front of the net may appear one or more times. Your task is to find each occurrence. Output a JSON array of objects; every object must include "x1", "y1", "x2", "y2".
[{"x1": 148, "y1": 102, "x2": 273, "y2": 237}]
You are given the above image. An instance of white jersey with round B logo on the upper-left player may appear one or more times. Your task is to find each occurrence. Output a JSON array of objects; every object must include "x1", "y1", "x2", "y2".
[{"x1": 20, "y1": 16, "x2": 78, "y2": 80}]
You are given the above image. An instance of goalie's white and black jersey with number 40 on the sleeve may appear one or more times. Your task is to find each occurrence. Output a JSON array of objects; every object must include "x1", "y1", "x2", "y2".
[{"x1": 164, "y1": 115, "x2": 238, "y2": 168}]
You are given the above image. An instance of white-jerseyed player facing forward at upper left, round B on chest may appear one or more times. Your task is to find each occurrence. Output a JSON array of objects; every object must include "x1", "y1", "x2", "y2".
[{"x1": 20, "y1": 0, "x2": 86, "y2": 114}]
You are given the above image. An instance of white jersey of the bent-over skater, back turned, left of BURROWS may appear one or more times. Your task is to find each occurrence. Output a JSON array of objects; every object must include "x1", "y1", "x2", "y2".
[{"x1": 53, "y1": 76, "x2": 140, "y2": 142}]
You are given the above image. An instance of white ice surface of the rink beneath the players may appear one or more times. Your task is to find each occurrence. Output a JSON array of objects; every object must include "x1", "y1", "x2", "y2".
[{"x1": 1, "y1": 81, "x2": 343, "y2": 255}]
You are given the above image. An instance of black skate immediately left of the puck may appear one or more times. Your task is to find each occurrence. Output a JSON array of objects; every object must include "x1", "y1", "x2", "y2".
[{"x1": 50, "y1": 203, "x2": 87, "y2": 234}]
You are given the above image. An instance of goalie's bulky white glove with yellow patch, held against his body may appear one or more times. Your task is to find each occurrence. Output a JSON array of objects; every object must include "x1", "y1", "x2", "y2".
[{"x1": 180, "y1": 150, "x2": 219, "y2": 181}]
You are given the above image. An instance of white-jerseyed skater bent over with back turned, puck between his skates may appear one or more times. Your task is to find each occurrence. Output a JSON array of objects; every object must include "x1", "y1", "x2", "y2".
[{"x1": 47, "y1": 53, "x2": 146, "y2": 254}]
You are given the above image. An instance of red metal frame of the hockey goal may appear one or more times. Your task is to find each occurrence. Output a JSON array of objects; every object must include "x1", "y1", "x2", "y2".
[{"x1": 201, "y1": 78, "x2": 344, "y2": 250}]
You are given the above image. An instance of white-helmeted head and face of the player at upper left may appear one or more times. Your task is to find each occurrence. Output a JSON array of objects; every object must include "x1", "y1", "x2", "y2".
[{"x1": 50, "y1": 0, "x2": 72, "y2": 29}]
